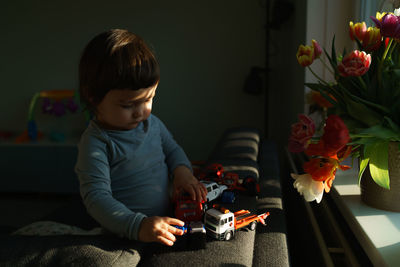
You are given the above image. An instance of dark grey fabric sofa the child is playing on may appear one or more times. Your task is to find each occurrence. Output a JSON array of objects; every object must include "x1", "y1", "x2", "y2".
[{"x1": 0, "y1": 128, "x2": 289, "y2": 266}]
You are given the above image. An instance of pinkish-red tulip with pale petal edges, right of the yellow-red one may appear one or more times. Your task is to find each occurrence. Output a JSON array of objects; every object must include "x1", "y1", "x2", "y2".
[{"x1": 338, "y1": 50, "x2": 371, "y2": 77}]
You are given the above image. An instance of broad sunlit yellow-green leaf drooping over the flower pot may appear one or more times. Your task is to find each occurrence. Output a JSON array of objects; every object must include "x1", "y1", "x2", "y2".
[{"x1": 369, "y1": 142, "x2": 390, "y2": 189}]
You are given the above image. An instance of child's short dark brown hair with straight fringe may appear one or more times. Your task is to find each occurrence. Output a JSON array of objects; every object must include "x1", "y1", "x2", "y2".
[{"x1": 79, "y1": 29, "x2": 160, "y2": 112}]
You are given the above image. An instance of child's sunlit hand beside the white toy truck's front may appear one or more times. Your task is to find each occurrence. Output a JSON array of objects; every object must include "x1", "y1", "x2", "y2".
[{"x1": 138, "y1": 216, "x2": 185, "y2": 246}]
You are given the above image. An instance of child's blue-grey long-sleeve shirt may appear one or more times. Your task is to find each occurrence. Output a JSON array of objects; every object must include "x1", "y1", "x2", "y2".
[{"x1": 75, "y1": 115, "x2": 191, "y2": 240}]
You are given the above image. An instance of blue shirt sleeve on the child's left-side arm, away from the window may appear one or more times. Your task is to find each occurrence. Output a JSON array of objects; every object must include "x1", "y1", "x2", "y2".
[{"x1": 75, "y1": 131, "x2": 146, "y2": 240}]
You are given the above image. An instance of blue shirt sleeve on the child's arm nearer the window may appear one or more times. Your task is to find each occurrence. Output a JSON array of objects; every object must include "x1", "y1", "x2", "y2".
[{"x1": 154, "y1": 116, "x2": 193, "y2": 172}]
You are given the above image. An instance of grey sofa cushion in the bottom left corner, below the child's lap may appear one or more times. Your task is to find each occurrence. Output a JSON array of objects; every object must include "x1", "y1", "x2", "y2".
[{"x1": 0, "y1": 235, "x2": 141, "y2": 267}]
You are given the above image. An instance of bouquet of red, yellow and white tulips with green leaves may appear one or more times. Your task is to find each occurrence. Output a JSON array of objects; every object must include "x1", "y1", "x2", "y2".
[{"x1": 289, "y1": 10, "x2": 400, "y2": 202}]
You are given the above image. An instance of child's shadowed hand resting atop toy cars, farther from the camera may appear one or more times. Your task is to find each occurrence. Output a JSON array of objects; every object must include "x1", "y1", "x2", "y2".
[{"x1": 173, "y1": 166, "x2": 207, "y2": 202}]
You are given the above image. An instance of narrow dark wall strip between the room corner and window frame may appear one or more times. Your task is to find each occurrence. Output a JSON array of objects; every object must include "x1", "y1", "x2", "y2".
[{"x1": 267, "y1": 0, "x2": 307, "y2": 160}]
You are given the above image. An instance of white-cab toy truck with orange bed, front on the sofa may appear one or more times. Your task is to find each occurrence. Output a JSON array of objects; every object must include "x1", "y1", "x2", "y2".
[{"x1": 204, "y1": 206, "x2": 269, "y2": 240}]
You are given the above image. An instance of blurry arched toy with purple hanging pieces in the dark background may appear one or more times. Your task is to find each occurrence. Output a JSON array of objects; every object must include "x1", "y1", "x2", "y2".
[{"x1": 15, "y1": 90, "x2": 88, "y2": 143}]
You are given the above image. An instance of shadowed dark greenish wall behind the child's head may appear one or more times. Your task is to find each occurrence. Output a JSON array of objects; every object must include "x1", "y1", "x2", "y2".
[{"x1": 0, "y1": 0, "x2": 265, "y2": 159}]
